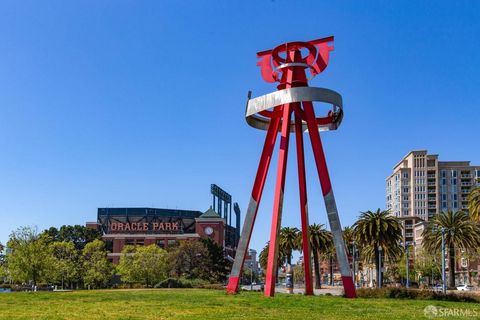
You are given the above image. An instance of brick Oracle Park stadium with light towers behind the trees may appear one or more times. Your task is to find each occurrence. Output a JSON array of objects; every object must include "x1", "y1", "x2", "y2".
[{"x1": 86, "y1": 184, "x2": 240, "y2": 264}]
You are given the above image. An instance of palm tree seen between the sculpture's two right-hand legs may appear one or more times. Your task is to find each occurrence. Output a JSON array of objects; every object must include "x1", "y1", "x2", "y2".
[{"x1": 308, "y1": 223, "x2": 333, "y2": 289}]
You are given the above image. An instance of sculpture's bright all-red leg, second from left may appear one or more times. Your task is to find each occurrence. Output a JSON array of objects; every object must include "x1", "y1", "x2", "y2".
[{"x1": 265, "y1": 104, "x2": 292, "y2": 297}]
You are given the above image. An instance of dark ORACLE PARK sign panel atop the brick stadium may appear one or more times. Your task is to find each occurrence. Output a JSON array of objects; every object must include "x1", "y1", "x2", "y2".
[{"x1": 97, "y1": 208, "x2": 202, "y2": 234}]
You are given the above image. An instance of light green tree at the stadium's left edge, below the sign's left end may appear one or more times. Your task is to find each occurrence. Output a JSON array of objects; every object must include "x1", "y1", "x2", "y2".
[{"x1": 82, "y1": 240, "x2": 113, "y2": 289}]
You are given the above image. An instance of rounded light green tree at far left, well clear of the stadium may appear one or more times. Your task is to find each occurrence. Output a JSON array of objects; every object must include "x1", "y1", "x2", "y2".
[{"x1": 6, "y1": 227, "x2": 52, "y2": 286}]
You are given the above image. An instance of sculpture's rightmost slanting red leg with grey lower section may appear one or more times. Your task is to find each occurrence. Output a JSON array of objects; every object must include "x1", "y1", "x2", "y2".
[{"x1": 303, "y1": 102, "x2": 357, "y2": 298}]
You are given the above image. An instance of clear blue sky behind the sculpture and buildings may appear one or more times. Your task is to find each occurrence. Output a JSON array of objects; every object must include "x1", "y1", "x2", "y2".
[{"x1": 0, "y1": 0, "x2": 480, "y2": 249}]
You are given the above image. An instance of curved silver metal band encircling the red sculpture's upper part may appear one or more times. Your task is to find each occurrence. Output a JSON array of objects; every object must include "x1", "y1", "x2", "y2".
[{"x1": 245, "y1": 87, "x2": 343, "y2": 132}]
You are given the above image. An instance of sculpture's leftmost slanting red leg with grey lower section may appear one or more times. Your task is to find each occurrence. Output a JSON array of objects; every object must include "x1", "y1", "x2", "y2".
[{"x1": 227, "y1": 117, "x2": 280, "y2": 293}]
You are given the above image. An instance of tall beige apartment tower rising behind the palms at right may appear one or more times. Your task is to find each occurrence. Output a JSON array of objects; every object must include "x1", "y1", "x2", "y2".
[{"x1": 386, "y1": 150, "x2": 480, "y2": 241}]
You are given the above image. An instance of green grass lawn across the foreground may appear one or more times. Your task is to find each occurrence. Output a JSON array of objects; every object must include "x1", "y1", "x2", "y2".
[{"x1": 0, "y1": 289, "x2": 480, "y2": 320}]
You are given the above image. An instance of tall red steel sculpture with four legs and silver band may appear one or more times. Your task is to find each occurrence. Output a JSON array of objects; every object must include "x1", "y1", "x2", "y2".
[{"x1": 227, "y1": 37, "x2": 356, "y2": 298}]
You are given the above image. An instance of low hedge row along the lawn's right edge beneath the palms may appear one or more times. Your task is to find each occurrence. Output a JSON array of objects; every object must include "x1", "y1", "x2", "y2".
[{"x1": 357, "y1": 288, "x2": 480, "y2": 302}]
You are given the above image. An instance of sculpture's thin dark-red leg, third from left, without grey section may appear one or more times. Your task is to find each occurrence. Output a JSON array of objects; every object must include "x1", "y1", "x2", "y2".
[{"x1": 295, "y1": 103, "x2": 313, "y2": 295}]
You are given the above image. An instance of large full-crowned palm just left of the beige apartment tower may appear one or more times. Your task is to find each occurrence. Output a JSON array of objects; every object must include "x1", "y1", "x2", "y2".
[{"x1": 353, "y1": 209, "x2": 402, "y2": 286}]
